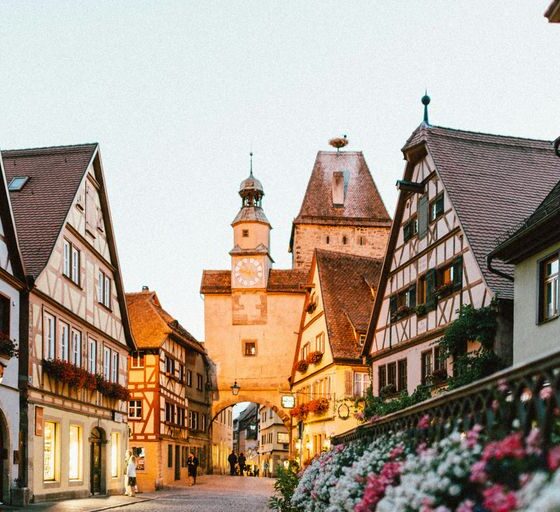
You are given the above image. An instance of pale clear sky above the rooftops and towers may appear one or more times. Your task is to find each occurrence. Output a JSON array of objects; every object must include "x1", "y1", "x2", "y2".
[{"x1": 0, "y1": 4, "x2": 560, "y2": 340}]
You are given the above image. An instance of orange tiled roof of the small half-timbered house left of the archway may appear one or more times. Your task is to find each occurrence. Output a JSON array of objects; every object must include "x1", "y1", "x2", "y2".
[{"x1": 126, "y1": 291, "x2": 206, "y2": 354}]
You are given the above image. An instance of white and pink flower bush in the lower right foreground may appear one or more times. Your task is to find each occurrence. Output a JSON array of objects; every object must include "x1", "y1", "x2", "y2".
[{"x1": 284, "y1": 415, "x2": 560, "y2": 512}]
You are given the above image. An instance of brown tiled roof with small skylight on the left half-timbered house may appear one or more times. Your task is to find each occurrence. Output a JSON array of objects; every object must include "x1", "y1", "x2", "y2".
[{"x1": 2, "y1": 144, "x2": 97, "y2": 278}]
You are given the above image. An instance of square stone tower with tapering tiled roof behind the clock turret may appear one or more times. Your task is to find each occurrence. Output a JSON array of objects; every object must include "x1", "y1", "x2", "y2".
[{"x1": 290, "y1": 144, "x2": 391, "y2": 270}]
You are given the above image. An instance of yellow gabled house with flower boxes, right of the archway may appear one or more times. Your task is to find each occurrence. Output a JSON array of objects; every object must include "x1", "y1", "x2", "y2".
[{"x1": 290, "y1": 249, "x2": 382, "y2": 463}]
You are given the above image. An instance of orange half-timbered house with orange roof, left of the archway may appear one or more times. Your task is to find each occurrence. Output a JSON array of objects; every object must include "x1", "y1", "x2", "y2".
[{"x1": 127, "y1": 289, "x2": 210, "y2": 491}]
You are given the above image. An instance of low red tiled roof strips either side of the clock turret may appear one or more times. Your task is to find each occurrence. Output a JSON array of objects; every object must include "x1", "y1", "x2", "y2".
[{"x1": 200, "y1": 269, "x2": 307, "y2": 294}]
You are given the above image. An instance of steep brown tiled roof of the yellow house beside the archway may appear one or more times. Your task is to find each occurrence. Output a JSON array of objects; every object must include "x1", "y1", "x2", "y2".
[{"x1": 315, "y1": 249, "x2": 383, "y2": 360}]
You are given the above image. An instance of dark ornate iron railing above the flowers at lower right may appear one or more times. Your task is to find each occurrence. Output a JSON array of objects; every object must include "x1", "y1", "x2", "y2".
[{"x1": 333, "y1": 352, "x2": 560, "y2": 447}]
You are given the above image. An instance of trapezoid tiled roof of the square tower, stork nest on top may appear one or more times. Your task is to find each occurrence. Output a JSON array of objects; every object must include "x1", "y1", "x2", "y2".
[{"x1": 294, "y1": 151, "x2": 391, "y2": 226}]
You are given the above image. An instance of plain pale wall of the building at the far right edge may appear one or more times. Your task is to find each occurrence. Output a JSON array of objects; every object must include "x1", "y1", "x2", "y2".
[{"x1": 513, "y1": 243, "x2": 560, "y2": 364}]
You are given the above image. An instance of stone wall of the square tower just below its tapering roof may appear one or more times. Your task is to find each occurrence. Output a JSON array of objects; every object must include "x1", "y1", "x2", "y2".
[{"x1": 292, "y1": 224, "x2": 390, "y2": 270}]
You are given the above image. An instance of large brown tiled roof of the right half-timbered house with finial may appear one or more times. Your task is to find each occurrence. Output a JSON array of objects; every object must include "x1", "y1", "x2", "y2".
[{"x1": 364, "y1": 123, "x2": 560, "y2": 354}]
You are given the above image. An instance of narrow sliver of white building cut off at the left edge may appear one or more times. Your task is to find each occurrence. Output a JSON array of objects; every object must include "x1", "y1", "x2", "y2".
[{"x1": 0, "y1": 152, "x2": 25, "y2": 504}]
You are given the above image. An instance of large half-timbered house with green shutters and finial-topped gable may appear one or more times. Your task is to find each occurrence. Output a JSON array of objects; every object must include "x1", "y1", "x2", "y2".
[{"x1": 364, "y1": 122, "x2": 559, "y2": 395}]
